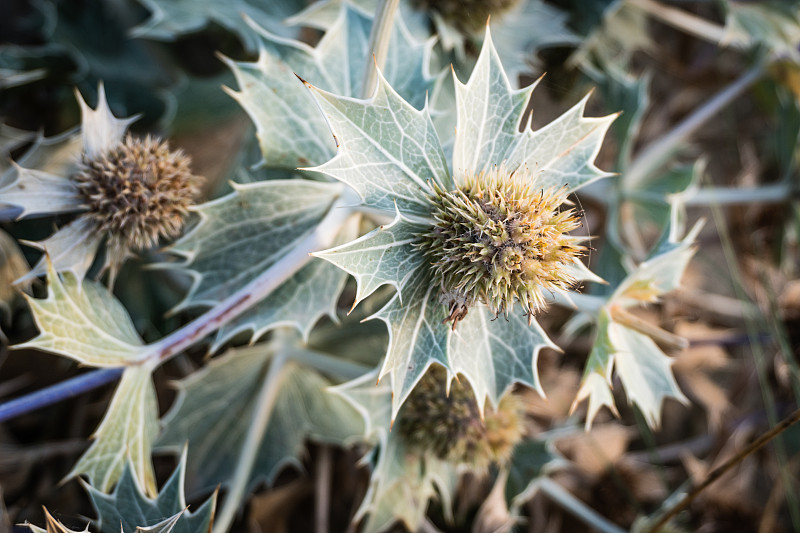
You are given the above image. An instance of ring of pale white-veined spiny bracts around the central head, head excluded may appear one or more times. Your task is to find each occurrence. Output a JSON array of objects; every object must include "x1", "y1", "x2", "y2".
[{"x1": 311, "y1": 28, "x2": 614, "y2": 415}]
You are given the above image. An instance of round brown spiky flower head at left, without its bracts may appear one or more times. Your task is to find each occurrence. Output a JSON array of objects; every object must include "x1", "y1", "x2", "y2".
[{"x1": 72, "y1": 134, "x2": 201, "y2": 257}]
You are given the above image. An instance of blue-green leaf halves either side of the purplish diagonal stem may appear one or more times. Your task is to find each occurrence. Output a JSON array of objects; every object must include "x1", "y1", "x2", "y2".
[{"x1": 161, "y1": 179, "x2": 352, "y2": 345}]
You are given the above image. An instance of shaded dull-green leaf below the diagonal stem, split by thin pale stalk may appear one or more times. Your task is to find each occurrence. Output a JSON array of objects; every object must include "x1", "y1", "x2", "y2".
[{"x1": 158, "y1": 345, "x2": 361, "y2": 492}]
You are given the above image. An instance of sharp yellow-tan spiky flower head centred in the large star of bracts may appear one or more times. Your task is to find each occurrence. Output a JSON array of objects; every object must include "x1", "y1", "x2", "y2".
[{"x1": 416, "y1": 166, "x2": 585, "y2": 327}]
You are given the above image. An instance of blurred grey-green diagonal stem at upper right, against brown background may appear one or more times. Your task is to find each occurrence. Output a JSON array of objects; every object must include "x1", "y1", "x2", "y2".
[{"x1": 622, "y1": 65, "x2": 765, "y2": 190}]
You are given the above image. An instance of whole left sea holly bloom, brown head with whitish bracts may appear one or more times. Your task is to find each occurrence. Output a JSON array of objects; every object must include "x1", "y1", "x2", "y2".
[{"x1": 0, "y1": 84, "x2": 201, "y2": 280}]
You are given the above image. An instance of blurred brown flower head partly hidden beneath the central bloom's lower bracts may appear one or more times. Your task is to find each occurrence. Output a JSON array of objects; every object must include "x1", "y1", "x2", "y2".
[{"x1": 395, "y1": 366, "x2": 523, "y2": 469}]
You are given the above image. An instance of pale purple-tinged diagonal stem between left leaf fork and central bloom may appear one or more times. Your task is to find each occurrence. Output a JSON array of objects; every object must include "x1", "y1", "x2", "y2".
[{"x1": 142, "y1": 190, "x2": 355, "y2": 363}]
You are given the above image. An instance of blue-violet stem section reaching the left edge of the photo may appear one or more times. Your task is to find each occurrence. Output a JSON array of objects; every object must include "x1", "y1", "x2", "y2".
[{"x1": 0, "y1": 368, "x2": 123, "y2": 422}]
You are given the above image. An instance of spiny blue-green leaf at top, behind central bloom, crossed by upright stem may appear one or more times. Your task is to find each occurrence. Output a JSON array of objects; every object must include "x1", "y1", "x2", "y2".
[{"x1": 227, "y1": 4, "x2": 433, "y2": 168}]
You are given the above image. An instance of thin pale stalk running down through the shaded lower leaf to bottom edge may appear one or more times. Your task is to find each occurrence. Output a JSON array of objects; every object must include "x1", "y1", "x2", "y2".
[{"x1": 212, "y1": 349, "x2": 288, "y2": 533}]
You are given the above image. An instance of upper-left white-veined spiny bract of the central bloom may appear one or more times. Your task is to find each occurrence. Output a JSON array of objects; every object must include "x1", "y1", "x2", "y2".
[{"x1": 309, "y1": 71, "x2": 452, "y2": 217}]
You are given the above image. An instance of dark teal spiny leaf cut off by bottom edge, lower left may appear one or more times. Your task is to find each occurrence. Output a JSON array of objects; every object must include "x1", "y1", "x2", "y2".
[{"x1": 84, "y1": 449, "x2": 217, "y2": 533}]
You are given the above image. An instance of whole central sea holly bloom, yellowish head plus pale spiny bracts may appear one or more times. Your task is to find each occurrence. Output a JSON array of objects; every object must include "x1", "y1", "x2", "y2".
[{"x1": 309, "y1": 31, "x2": 614, "y2": 417}]
